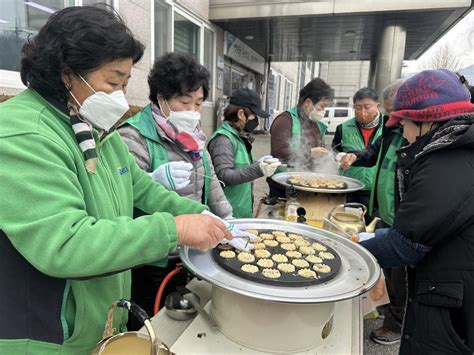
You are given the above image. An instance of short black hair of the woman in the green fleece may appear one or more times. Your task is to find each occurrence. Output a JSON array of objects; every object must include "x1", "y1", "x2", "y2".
[{"x1": 20, "y1": 6, "x2": 145, "y2": 104}]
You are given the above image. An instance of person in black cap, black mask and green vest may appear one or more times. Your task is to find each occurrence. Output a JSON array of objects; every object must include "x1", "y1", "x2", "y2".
[{"x1": 208, "y1": 88, "x2": 280, "y2": 218}]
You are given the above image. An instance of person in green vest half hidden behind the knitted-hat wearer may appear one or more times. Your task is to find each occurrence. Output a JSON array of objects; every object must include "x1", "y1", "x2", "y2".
[{"x1": 341, "y1": 79, "x2": 406, "y2": 345}]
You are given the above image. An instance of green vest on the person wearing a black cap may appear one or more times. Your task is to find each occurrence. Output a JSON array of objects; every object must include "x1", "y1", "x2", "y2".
[{"x1": 209, "y1": 121, "x2": 254, "y2": 218}]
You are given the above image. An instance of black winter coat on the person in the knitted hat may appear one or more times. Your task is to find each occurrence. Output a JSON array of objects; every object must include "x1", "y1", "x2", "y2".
[{"x1": 382, "y1": 114, "x2": 474, "y2": 354}]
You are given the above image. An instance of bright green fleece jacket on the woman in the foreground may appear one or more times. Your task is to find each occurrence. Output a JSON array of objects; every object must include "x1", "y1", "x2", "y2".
[{"x1": 0, "y1": 89, "x2": 205, "y2": 355}]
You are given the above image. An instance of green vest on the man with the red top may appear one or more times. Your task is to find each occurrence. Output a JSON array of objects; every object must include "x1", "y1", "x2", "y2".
[{"x1": 342, "y1": 118, "x2": 383, "y2": 190}]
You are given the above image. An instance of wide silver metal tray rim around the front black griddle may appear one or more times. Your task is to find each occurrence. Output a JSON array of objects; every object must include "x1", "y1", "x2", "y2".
[{"x1": 180, "y1": 219, "x2": 380, "y2": 304}]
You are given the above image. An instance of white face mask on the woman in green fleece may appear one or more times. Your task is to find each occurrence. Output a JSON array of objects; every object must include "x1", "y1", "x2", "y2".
[{"x1": 69, "y1": 75, "x2": 129, "y2": 131}]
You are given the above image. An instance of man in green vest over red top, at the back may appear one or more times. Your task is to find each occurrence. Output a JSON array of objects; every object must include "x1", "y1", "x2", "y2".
[{"x1": 332, "y1": 88, "x2": 383, "y2": 210}]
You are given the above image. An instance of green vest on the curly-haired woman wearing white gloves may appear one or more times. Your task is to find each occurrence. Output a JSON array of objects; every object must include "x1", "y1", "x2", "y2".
[{"x1": 126, "y1": 105, "x2": 211, "y2": 267}]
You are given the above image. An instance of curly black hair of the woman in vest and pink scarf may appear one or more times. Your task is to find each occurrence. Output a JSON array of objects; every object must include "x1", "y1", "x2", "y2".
[{"x1": 148, "y1": 53, "x2": 210, "y2": 104}]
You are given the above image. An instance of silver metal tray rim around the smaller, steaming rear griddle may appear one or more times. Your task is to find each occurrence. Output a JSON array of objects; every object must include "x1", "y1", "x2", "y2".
[{"x1": 272, "y1": 171, "x2": 364, "y2": 194}]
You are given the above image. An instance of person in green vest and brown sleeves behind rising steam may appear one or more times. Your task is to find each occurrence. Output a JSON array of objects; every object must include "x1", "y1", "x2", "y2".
[{"x1": 267, "y1": 78, "x2": 334, "y2": 197}]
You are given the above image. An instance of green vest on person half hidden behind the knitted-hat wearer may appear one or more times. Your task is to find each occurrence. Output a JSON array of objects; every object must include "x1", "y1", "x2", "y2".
[{"x1": 369, "y1": 130, "x2": 403, "y2": 225}]
